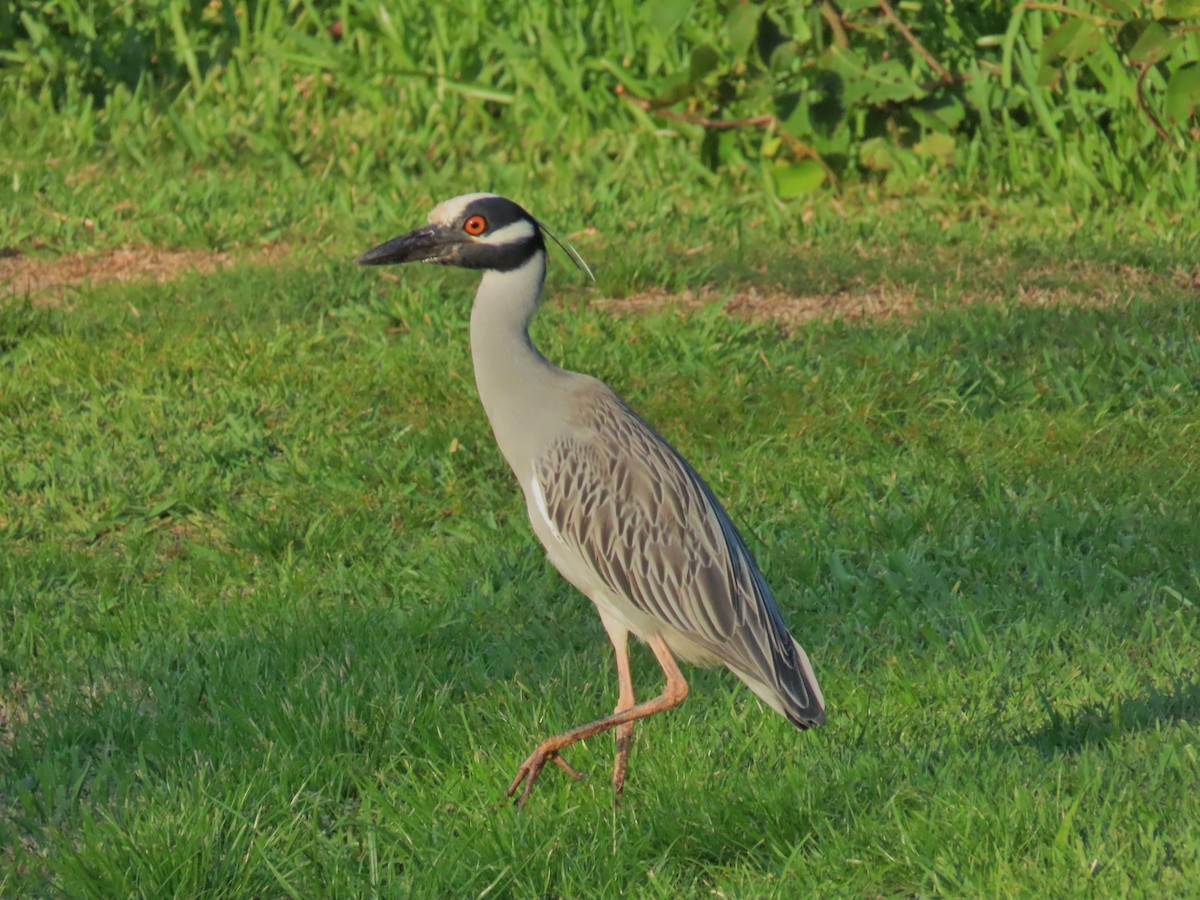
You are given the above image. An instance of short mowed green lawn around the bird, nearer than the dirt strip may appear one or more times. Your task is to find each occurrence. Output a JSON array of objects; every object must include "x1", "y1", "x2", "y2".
[{"x1": 0, "y1": 243, "x2": 1200, "y2": 898}]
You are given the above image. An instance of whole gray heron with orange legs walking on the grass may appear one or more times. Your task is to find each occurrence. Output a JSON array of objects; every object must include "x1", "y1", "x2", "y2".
[{"x1": 356, "y1": 193, "x2": 824, "y2": 808}]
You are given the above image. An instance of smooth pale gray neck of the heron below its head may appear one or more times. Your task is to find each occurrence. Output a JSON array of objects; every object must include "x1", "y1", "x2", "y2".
[{"x1": 470, "y1": 252, "x2": 569, "y2": 486}]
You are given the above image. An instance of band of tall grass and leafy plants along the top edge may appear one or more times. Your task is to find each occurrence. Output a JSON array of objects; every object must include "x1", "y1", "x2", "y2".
[{"x1": 0, "y1": 0, "x2": 1200, "y2": 206}]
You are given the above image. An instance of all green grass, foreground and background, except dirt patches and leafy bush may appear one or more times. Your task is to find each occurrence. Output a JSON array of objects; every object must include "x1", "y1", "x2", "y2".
[{"x1": 0, "y1": 0, "x2": 1200, "y2": 898}]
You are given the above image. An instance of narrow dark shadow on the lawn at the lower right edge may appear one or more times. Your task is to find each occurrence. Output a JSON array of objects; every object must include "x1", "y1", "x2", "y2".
[{"x1": 1025, "y1": 673, "x2": 1200, "y2": 756}]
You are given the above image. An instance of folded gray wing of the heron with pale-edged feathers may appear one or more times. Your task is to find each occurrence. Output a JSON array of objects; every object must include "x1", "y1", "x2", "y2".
[{"x1": 536, "y1": 382, "x2": 824, "y2": 728}]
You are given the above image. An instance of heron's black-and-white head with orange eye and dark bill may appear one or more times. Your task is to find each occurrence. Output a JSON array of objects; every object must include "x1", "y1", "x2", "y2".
[{"x1": 358, "y1": 193, "x2": 546, "y2": 271}]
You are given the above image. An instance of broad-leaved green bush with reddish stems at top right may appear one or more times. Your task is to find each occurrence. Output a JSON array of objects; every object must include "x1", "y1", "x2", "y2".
[{"x1": 635, "y1": 0, "x2": 1200, "y2": 197}]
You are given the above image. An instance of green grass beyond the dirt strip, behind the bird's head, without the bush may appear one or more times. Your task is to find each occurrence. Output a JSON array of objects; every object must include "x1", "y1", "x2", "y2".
[{"x1": 0, "y1": 0, "x2": 1200, "y2": 260}]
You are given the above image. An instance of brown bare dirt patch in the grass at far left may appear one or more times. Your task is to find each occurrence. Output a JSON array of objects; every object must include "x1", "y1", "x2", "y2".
[{"x1": 0, "y1": 244, "x2": 289, "y2": 306}]
